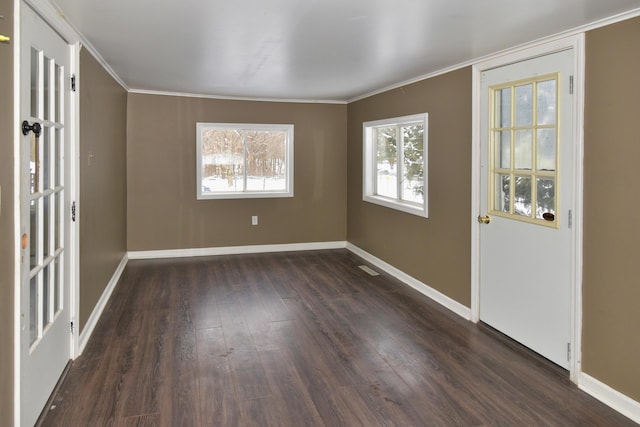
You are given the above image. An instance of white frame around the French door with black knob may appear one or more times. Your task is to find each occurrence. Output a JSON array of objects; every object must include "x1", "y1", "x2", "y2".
[{"x1": 12, "y1": 0, "x2": 81, "y2": 427}]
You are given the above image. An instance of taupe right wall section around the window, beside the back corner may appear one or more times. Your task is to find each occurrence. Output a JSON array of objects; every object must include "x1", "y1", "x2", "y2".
[{"x1": 348, "y1": 68, "x2": 472, "y2": 306}]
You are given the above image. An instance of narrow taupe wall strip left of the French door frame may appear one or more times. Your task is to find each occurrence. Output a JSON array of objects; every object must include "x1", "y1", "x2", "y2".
[{"x1": 0, "y1": 0, "x2": 16, "y2": 426}]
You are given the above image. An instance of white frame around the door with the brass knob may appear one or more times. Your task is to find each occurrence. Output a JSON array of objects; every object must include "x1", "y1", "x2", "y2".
[{"x1": 470, "y1": 33, "x2": 585, "y2": 383}]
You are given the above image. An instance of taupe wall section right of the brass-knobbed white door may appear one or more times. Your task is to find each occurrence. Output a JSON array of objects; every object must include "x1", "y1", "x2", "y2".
[{"x1": 583, "y1": 18, "x2": 640, "y2": 401}]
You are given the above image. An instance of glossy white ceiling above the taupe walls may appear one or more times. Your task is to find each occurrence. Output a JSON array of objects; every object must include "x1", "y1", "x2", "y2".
[{"x1": 52, "y1": 0, "x2": 640, "y2": 101}]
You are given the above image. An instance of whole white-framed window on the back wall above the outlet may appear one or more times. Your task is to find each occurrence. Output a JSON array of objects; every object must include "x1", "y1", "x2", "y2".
[{"x1": 196, "y1": 123, "x2": 293, "y2": 199}]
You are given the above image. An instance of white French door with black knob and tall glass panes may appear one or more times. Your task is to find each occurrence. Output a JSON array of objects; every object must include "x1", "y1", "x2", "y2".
[{"x1": 20, "y1": 4, "x2": 72, "y2": 426}]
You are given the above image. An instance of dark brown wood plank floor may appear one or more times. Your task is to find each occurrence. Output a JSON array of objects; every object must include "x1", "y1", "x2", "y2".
[{"x1": 42, "y1": 250, "x2": 635, "y2": 427}]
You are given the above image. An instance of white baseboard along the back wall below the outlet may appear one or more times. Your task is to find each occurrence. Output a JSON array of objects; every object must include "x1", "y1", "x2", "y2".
[{"x1": 129, "y1": 241, "x2": 347, "y2": 259}]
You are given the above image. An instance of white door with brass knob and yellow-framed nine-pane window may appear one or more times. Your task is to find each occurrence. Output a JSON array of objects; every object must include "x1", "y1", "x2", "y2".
[{"x1": 478, "y1": 49, "x2": 575, "y2": 368}]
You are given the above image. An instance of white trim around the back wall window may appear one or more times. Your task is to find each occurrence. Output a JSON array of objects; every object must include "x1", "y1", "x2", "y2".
[{"x1": 196, "y1": 122, "x2": 294, "y2": 200}]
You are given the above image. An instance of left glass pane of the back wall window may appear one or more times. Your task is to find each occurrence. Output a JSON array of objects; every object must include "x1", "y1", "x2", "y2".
[{"x1": 201, "y1": 129, "x2": 244, "y2": 193}]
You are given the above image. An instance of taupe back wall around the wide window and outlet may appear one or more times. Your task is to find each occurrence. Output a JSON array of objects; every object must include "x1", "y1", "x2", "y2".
[{"x1": 127, "y1": 93, "x2": 346, "y2": 251}]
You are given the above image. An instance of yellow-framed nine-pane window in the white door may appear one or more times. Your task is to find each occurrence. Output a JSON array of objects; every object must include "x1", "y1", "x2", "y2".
[{"x1": 490, "y1": 74, "x2": 559, "y2": 227}]
